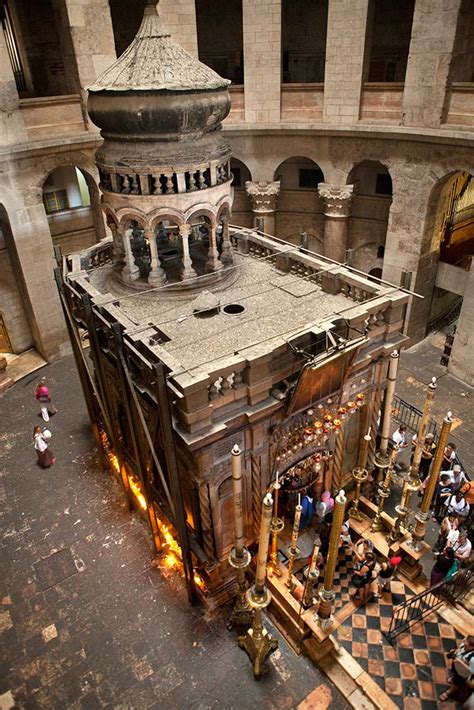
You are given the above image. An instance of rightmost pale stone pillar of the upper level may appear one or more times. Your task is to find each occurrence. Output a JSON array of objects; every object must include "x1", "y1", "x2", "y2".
[{"x1": 402, "y1": 0, "x2": 461, "y2": 128}]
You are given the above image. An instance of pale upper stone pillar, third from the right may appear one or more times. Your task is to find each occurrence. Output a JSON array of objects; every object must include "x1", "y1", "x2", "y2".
[{"x1": 242, "y1": 0, "x2": 281, "y2": 123}]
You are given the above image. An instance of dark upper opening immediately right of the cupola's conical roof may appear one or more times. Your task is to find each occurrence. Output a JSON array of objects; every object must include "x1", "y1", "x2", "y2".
[{"x1": 196, "y1": 0, "x2": 244, "y2": 84}]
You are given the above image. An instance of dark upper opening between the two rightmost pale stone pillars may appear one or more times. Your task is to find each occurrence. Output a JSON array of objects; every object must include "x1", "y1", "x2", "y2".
[{"x1": 366, "y1": 0, "x2": 415, "y2": 82}]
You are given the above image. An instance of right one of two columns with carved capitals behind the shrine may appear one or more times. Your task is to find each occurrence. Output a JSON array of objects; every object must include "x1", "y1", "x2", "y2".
[{"x1": 318, "y1": 182, "x2": 354, "y2": 263}]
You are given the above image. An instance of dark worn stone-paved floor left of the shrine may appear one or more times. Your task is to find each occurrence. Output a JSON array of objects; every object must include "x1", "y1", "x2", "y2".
[{"x1": 0, "y1": 358, "x2": 348, "y2": 710}]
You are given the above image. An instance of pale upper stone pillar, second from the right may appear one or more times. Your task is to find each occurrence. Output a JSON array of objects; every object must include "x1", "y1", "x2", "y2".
[{"x1": 323, "y1": 0, "x2": 370, "y2": 124}]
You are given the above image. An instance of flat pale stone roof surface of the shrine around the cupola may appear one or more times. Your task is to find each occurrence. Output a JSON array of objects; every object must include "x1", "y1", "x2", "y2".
[{"x1": 90, "y1": 249, "x2": 355, "y2": 369}]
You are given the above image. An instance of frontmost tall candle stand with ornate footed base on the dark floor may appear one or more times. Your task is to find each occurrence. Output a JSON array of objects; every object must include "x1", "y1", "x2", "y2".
[{"x1": 238, "y1": 493, "x2": 278, "y2": 678}]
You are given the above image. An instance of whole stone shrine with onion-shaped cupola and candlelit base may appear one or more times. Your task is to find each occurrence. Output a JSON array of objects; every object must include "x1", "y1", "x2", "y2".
[{"x1": 57, "y1": 3, "x2": 409, "y2": 603}]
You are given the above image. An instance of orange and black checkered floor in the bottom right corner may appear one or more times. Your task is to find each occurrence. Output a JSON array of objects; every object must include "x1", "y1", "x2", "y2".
[{"x1": 337, "y1": 581, "x2": 461, "y2": 710}]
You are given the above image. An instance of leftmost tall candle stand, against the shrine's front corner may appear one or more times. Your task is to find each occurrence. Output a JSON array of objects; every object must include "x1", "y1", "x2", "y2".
[{"x1": 228, "y1": 445, "x2": 252, "y2": 628}]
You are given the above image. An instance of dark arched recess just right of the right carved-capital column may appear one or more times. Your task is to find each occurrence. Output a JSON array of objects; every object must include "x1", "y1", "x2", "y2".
[{"x1": 347, "y1": 160, "x2": 392, "y2": 276}]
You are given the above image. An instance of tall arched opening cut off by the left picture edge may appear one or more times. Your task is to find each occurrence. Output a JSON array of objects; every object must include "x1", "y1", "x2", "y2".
[{"x1": 0, "y1": 205, "x2": 33, "y2": 353}]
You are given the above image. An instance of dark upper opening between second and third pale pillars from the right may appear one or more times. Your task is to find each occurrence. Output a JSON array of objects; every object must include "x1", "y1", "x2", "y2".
[{"x1": 281, "y1": 0, "x2": 328, "y2": 84}]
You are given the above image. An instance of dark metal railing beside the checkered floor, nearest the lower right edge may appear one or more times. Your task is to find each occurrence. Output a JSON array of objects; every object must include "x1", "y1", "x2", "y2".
[{"x1": 384, "y1": 563, "x2": 474, "y2": 642}]
